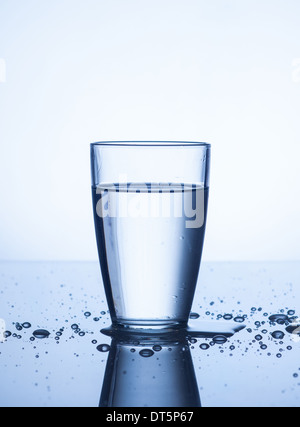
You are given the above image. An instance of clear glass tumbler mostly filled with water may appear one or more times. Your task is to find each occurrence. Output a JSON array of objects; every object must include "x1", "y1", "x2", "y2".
[{"x1": 91, "y1": 141, "x2": 210, "y2": 331}]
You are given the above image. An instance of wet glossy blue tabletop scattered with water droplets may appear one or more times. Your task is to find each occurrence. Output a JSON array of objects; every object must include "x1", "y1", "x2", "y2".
[{"x1": 0, "y1": 262, "x2": 300, "y2": 407}]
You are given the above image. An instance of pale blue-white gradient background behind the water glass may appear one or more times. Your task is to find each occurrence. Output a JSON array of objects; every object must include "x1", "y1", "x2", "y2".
[{"x1": 0, "y1": 0, "x2": 300, "y2": 261}]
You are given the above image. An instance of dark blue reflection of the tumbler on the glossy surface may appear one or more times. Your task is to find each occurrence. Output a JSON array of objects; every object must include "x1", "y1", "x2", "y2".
[{"x1": 99, "y1": 336, "x2": 201, "y2": 407}]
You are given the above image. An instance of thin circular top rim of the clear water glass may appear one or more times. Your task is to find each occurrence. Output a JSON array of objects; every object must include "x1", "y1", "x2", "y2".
[{"x1": 90, "y1": 141, "x2": 211, "y2": 148}]
